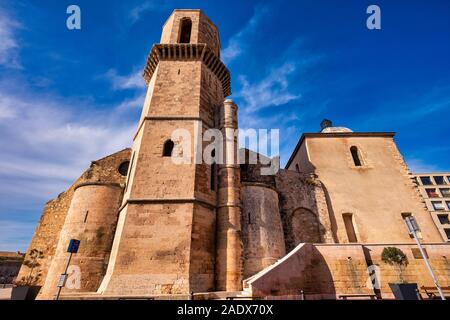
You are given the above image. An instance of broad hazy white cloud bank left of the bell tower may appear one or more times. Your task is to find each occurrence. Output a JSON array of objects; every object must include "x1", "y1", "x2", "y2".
[{"x1": 0, "y1": 86, "x2": 136, "y2": 200}]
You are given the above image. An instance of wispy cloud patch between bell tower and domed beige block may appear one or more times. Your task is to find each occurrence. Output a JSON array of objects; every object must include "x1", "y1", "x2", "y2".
[{"x1": 233, "y1": 38, "x2": 330, "y2": 128}]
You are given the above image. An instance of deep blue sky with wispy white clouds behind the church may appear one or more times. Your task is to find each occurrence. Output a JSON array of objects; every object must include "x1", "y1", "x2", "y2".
[{"x1": 0, "y1": 0, "x2": 450, "y2": 251}]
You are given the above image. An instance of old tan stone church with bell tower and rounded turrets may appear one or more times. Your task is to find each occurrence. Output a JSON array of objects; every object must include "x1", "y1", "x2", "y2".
[{"x1": 18, "y1": 10, "x2": 450, "y2": 299}]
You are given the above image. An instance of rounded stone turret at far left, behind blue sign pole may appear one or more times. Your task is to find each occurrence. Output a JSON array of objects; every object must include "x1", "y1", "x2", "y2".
[{"x1": 39, "y1": 183, "x2": 123, "y2": 299}]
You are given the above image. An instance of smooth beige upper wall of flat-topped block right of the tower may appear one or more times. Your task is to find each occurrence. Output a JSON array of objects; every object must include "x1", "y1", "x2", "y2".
[{"x1": 289, "y1": 132, "x2": 443, "y2": 243}]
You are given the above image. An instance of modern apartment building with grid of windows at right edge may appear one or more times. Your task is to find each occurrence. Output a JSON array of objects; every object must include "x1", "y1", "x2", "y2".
[{"x1": 415, "y1": 172, "x2": 450, "y2": 242}]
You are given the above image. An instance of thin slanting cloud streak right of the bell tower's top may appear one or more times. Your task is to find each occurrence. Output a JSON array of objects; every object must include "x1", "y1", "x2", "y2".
[{"x1": 221, "y1": 6, "x2": 268, "y2": 64}]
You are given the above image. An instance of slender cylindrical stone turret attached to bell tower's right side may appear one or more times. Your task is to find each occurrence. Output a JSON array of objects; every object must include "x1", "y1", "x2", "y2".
[{"x1": 216, "y1": 100, "x2": 242, "y2": 291}]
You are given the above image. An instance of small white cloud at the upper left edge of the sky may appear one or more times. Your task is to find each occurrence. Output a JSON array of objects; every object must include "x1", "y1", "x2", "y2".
[{"x1": 0, "y1": 7, "x2": 22, "y2": 69}]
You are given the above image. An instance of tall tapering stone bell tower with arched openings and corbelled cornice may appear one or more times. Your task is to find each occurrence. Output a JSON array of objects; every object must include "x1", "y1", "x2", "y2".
[{"x1": 98, "y1": 10, "x2": 236, "y2": 295}]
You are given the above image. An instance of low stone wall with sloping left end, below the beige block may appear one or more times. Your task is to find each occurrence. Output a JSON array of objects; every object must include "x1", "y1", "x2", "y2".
[{"x1": 248, "y1": 243, "x2": 450, "y2": 299}]
